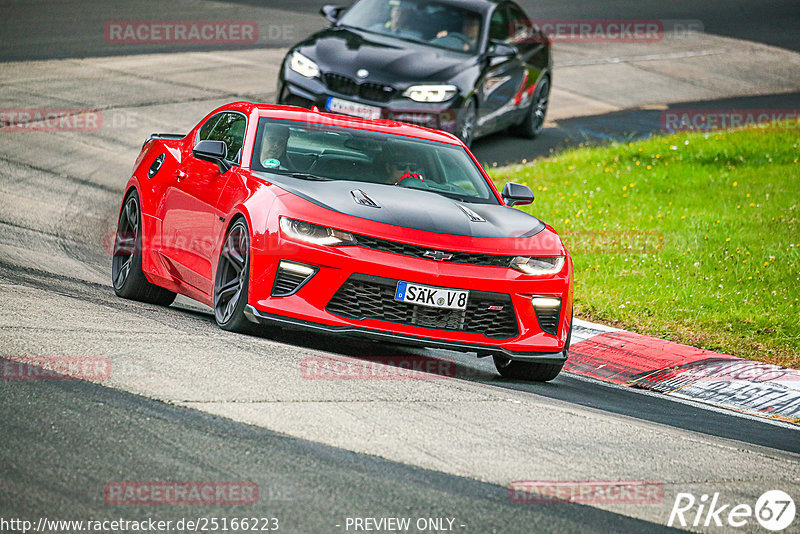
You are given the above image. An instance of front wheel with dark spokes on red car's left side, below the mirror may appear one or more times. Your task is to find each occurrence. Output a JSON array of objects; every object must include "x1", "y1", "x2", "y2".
[{"x1": 214, "y1": 217, "x2": 255, "y2": 333}]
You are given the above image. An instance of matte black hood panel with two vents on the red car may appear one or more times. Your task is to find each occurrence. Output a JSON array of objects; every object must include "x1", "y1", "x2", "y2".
[{"x1": 254, "y1": 173, "x2": 544, "y2": 238}]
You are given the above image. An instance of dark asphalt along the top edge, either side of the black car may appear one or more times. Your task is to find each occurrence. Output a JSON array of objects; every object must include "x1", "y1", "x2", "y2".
[{"x1": 0, "y1": 0, "x2": 800, "y2": 61}]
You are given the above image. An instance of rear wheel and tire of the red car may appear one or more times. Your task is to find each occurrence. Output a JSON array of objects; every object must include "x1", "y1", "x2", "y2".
[{"x1": 111, "y1": 190, "x2": 175, "y2": 306}]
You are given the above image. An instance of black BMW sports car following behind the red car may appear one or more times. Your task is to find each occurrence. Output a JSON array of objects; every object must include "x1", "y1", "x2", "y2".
[{"x1": 277, "y1": 0, "x2": 552, "y2": 146}]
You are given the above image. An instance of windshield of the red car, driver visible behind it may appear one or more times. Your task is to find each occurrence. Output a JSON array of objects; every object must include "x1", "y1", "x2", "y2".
[{"x1": 250, "y1": 118, "x2": 498, "y2": 204}]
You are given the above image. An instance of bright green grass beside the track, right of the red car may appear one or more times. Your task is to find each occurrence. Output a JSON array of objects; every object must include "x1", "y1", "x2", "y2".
[{"x1": 490, "y1": 129, "x2": 800, "y2": 368}]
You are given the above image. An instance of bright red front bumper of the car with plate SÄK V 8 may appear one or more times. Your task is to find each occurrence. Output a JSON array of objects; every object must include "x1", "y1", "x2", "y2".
[{"x1": 246, "y1": 224, "x2": 572, "y2": 362}]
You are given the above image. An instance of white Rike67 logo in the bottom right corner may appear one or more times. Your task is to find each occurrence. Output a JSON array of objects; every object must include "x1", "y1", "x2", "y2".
[{"x1": 667, "y1": 490, "x2": 796, "y2": 532}]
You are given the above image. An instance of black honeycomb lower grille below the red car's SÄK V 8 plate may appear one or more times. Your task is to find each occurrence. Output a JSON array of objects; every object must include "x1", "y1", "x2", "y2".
[{"x1": 325, "y1": 274, "x2": 519, "y2": 339}]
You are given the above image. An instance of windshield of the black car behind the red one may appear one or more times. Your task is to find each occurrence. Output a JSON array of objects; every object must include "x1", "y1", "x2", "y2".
[{"x1": 341, "y1": 0, "x2": 481, "y2": 52}]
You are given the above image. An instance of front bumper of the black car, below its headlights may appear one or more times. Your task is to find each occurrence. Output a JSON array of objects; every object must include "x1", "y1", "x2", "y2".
[{"x1": 276, "y1": 67, "x2": 463, "y2": 133}]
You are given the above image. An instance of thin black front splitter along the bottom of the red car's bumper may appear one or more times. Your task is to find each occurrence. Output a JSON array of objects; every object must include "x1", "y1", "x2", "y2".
[{"x1": 244, "y1": 304, "x2": 567, "y2": 363}]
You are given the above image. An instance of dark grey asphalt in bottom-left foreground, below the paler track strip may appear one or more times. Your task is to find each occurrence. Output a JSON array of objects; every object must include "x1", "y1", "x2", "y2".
[{"x1": 0, "y1": 364, "x2": 672, "y2": 533}]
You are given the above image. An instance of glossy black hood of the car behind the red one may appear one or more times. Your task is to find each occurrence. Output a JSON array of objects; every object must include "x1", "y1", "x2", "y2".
[{"x1": 297, "y1": 26, "x2": 477, "y2": 84}]
